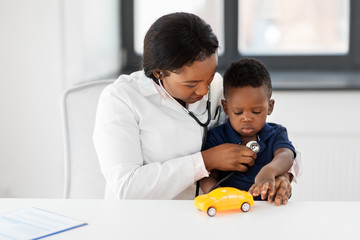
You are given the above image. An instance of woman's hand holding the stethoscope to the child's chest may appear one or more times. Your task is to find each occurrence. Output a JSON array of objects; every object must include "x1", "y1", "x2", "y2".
[{"x1": 201, "y1": 143, "x2": 256, "y2": 172}]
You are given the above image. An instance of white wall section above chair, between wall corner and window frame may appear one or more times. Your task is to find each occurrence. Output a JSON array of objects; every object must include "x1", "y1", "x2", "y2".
[{"x1": 61, "y1": 0, "x2": 121, "y2": 88}]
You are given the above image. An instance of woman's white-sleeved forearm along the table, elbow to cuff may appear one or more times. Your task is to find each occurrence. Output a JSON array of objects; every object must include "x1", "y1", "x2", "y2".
[{"x1": 104, "y1": 156, "x2": 194, "y2": 200}]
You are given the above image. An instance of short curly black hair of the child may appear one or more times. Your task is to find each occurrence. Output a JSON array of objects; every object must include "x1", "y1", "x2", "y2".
[{"x1": 223, "y1": 58, "x2": 272, "y2": 99}]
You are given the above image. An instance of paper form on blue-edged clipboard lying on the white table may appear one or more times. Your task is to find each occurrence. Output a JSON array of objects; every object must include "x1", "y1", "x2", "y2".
[{"x1": 0, "y1": 208, "x2": 87, "y2": 240}]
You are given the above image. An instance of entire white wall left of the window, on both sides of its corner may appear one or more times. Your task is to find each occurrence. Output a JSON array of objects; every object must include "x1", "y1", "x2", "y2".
[{"x1": 0, "y1": 0, "x2": 120, "y2": 198}]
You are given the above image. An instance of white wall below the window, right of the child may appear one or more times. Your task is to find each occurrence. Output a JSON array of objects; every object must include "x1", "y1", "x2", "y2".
[{"x1": 269, "y1": 91, "x2": 360, "y2": 201}]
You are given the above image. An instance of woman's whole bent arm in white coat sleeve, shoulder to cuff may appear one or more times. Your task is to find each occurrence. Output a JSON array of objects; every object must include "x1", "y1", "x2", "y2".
[{"x1": 93, "y1": 87, "x2": 201, "y2": 199}]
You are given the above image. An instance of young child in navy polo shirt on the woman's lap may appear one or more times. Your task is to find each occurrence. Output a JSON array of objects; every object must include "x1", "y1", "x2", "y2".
[{"x1": 200, "y1": 58, "x2": 296, "y2": 200}]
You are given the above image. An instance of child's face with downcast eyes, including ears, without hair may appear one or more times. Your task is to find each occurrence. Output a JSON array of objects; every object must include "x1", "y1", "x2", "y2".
[{"x1": 223, "y1": 86, "x2": 274, "y2": 141}]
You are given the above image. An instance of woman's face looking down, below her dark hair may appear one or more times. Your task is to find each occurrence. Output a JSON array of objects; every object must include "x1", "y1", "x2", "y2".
[{"x1": 160, "y1": 54, "x2": 218, "y2": 105}]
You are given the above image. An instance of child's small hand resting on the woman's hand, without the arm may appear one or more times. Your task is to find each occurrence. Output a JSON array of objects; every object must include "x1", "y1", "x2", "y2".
[{"x1": 249, "y1": 167, "x2": 276, "y2": 200}]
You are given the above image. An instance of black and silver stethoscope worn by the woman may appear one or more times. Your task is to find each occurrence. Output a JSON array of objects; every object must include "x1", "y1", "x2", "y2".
[{"x1": 158, "y1": 78, "x2": 260, "y2": 197}]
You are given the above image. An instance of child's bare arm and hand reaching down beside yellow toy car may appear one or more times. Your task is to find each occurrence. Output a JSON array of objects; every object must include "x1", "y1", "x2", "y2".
[{"x1": 249, "y1": 148, "x2": 294, "y2": 200}]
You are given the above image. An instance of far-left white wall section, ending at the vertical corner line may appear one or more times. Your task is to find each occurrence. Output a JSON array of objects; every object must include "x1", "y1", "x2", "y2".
[{"x1": 0, "y1": 0, "x2": 63, "y2": 197}]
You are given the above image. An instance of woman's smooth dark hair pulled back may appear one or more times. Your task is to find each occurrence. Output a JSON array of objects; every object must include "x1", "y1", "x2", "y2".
[{"x1": 143, "y1": 12, "x2": 219, "y2": 83}]
